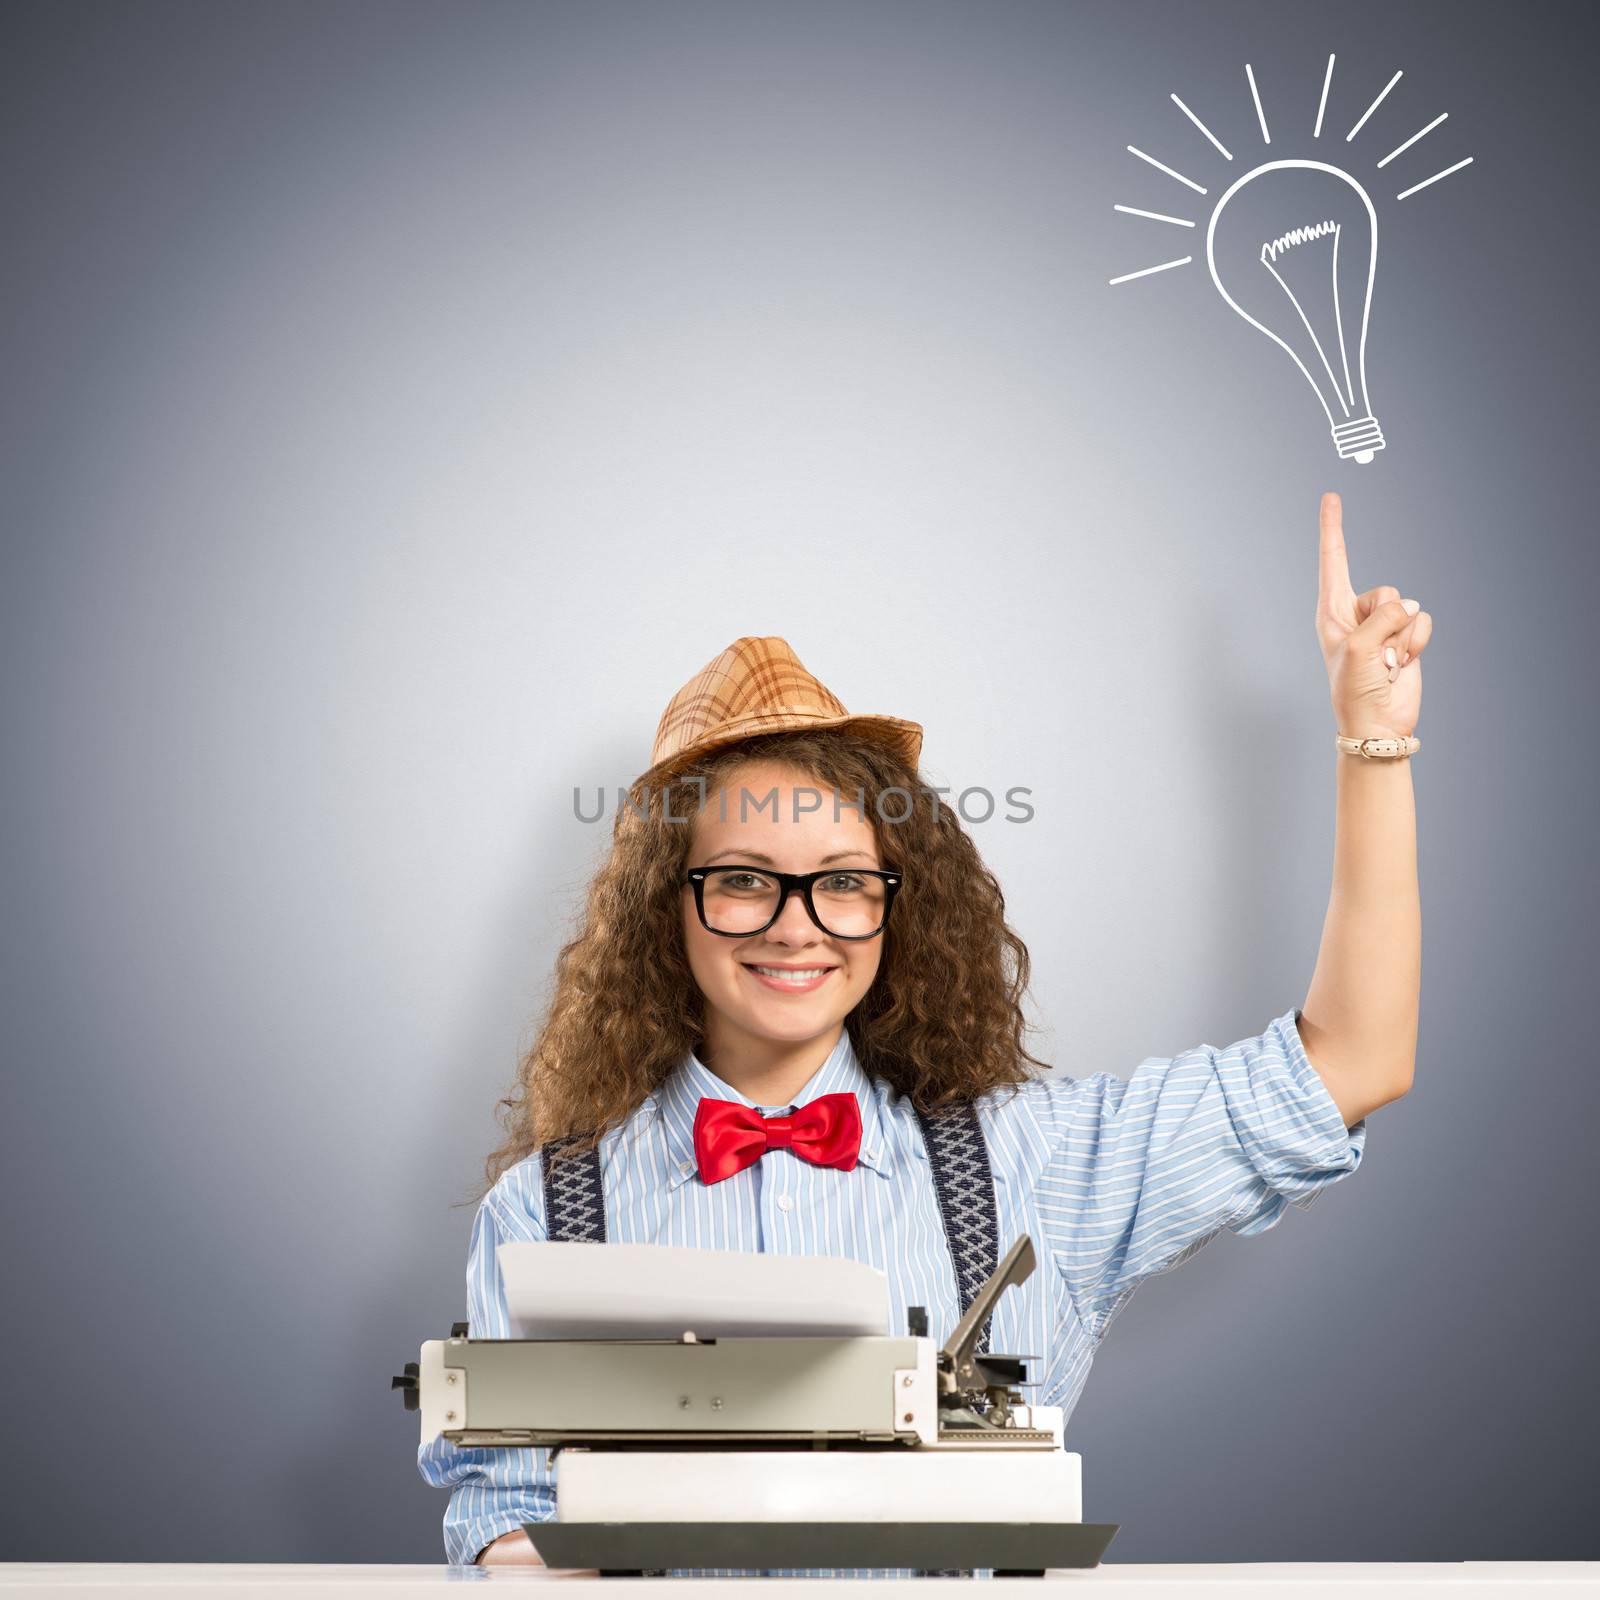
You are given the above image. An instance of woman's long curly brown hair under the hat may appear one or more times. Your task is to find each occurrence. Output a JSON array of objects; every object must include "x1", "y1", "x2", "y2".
[{"x1": 477, "y1": 728, "x2": 1045, "y2": 1200}]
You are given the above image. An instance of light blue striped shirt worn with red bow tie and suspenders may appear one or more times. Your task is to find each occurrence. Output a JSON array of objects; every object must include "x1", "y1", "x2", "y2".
[{"x1": 418, "y1": 1010, "x2": 1366, "y2": 1576}]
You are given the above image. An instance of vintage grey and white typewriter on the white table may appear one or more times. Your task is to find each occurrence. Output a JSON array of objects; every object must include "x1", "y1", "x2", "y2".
[{"x1": 390, "y1": 1234, "x2": 1117, "y2": 1576}]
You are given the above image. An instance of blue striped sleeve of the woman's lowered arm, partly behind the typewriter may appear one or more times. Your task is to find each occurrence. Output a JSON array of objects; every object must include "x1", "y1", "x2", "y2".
[{"x1": 416, "y1": 1157, "x2": 555, "y2": 1566}]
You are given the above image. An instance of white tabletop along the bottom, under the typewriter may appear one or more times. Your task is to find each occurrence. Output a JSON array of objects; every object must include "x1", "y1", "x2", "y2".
[{"x1": 0, "y1": 1562, "x2": 1600, "y2": 1600}]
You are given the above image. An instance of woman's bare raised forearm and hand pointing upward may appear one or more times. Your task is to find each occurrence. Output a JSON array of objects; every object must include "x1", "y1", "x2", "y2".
[{"x1": 1299, "y1": 494, "x2": 1434, "y2": 1126}]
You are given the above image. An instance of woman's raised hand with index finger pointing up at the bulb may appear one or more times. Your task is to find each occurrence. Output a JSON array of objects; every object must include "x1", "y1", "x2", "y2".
[{"x1": 1317, "y1": 491, "x2": 1434, "y2": 739}]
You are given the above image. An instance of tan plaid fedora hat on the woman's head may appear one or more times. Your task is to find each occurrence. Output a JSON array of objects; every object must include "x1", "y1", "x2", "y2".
[{"x1": 642, "y1": 635, "x2": 922, "y2": 781}]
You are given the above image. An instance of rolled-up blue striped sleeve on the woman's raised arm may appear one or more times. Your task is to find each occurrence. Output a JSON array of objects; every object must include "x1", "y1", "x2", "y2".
[{"x1": 1037, "y1": 1010, "x2": 1366, "y2": 1342}]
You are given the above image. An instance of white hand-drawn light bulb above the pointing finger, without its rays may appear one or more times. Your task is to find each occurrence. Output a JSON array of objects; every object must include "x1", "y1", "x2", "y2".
[{"x1": 1205, "y1": 160, "x2": 1384, "y2": 462}]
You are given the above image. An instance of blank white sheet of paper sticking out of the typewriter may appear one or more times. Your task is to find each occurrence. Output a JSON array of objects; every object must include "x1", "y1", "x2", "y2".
[{"x1": 498, "y1": 1240, "x2": 890, "y2": 1339}]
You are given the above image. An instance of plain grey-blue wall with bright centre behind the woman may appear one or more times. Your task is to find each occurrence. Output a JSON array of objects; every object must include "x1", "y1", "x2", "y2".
[{"x1": 0, "y1": 0, "x2": 1600, "y2": 1562}]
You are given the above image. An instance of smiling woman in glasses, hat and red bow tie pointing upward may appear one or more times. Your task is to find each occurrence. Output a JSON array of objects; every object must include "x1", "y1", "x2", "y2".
[{"x1": 418, "y1": 494, "x2": 1432, "y2": 1565}]
